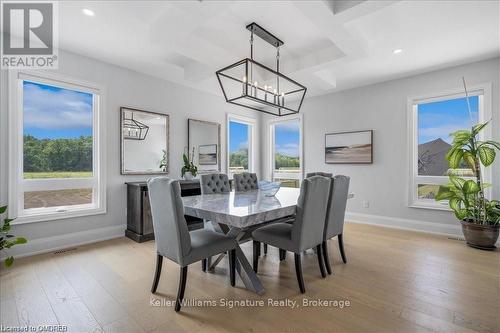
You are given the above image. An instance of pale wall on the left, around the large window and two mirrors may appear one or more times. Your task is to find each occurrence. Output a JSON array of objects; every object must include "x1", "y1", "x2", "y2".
[{"x1": 0, "y1": 51, "x2": 259, "y2": 253}]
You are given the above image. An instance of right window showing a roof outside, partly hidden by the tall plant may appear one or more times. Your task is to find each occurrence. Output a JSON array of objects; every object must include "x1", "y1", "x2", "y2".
[{"x1": 409, "y1": 87, "x2": 491, "y2": 209}]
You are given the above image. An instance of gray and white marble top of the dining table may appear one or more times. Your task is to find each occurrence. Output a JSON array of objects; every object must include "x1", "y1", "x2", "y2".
[{"x1": 182, "y1": 187, "x2": 300, "y2": 228}]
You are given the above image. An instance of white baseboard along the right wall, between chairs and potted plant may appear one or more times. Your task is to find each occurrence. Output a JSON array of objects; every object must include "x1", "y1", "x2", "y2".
[{"x1": 346, "y1": 213, "x2": 463, "y2": 237}]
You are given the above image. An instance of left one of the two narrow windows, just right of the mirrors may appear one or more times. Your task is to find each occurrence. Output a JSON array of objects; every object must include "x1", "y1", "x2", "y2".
[{"x1": 227, "y1": 115, "x2": 255, "y2": 178}]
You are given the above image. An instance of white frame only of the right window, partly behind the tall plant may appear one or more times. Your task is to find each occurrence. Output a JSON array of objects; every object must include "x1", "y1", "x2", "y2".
[{"x1": 407, "y1": 83, "x2": 493, "y2": 211}]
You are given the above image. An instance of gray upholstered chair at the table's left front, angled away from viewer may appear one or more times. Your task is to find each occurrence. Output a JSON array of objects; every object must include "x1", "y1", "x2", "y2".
[{"x1": 148, "y1": 177, "x2": 237, "y2": 312}]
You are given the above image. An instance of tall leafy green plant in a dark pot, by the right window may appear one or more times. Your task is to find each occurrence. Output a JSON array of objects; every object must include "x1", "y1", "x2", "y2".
[{"x1": 435, "y1": 122, "x2": 500, "y2": 250}]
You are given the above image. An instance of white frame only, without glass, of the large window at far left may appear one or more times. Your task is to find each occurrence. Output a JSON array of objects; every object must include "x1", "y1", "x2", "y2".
[{"x1": 8, "y1": 71, "x2": 106, "y2": 224}]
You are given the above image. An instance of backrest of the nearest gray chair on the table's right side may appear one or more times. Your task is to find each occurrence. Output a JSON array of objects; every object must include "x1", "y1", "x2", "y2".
[{"x1": 292, "y1": 176, "x2": 331, "y2": 251}]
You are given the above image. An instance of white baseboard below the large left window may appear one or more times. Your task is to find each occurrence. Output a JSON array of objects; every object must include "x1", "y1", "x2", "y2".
[{"x1": 1, "y1": 225, "x2": 127, "y2": 260}]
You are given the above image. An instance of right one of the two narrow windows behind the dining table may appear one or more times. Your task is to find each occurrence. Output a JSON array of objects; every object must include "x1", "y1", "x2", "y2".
[{"x1": 270, "y1": 117, "x2": 302, "y2": 187}]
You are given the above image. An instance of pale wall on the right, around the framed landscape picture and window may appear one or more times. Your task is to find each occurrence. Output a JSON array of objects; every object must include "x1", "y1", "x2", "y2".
[{"x1": 261, "y1": 58, "x2": 500, "y2": 233}]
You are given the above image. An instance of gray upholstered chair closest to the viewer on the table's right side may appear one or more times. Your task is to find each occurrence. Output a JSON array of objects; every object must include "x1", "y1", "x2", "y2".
[{"x1": 252, "y1": 176, "x2": 331, "y2": 293}]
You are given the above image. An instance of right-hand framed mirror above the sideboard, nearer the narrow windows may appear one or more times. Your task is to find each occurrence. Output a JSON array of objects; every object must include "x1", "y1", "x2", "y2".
[{"x1": 188, "y1": 119, "x2": 221, "y2": 173}]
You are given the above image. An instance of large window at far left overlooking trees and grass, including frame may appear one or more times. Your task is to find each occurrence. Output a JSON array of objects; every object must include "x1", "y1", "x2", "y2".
[{"x1": 9, "y1": 72, "x2": 105, "y2": 222}]
